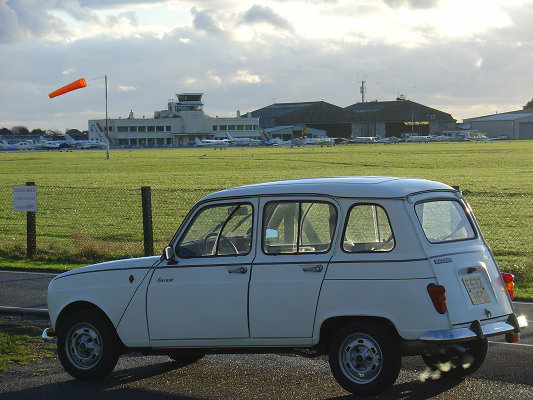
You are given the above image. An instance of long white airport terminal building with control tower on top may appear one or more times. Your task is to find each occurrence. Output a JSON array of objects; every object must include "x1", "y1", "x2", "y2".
[{"x1": 88, "y1": 93, "x2": 263, "y2": 147}]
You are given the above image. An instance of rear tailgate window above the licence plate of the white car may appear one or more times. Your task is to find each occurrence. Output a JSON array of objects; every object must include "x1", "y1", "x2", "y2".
[{"x1": 415, "y1": 200, "x2": 476, "y2": 243}]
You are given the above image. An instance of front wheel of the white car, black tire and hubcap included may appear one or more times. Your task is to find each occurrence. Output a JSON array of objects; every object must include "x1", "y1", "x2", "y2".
[{"x1": 57, "y1": 310, "x2": 119, "y2": 379}]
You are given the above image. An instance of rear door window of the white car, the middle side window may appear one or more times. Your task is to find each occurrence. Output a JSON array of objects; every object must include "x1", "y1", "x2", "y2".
[{"x1": 263, "y1": 201, "x2": 337, "y2": 254}]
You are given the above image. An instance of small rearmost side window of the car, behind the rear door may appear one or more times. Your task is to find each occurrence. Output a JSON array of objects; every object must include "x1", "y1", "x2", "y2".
[{"x1": 342, "y1": 204, "x2": 395, "y2": 253}]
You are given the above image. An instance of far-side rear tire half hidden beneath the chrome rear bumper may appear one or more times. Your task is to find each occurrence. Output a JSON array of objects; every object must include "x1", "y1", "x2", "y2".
[{"x1": 422, "y1": 338, "x2": 489, "y2": 378}]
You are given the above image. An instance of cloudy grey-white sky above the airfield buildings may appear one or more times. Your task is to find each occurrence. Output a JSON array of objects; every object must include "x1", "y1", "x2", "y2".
[{"x1": 0, "y1": 0, "x2": 533, "y2": 131}]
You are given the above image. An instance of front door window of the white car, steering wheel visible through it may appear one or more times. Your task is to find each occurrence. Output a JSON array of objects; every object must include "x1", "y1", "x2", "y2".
[{"x1": 178, "y1": 203, "x2": 253, "y2": 258}]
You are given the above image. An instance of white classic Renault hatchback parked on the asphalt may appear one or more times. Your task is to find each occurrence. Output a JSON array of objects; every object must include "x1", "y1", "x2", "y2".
[{"x1": 43, "y1": 177, "x2": 526, "y2": 394}]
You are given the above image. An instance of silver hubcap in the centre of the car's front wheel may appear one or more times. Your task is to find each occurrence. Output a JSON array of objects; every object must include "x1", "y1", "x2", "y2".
[{"x1": 65, "y1": 322, "x2": 102, "y2": 369}]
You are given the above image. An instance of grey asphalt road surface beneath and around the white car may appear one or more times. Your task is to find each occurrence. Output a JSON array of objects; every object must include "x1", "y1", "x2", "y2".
[{"x1": 0, "y1": 272, "x2": 533, "y2": 400}]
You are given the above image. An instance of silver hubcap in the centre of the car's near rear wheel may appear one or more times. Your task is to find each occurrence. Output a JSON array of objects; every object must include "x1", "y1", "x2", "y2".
[{"x1": 339, "y1": 333, "x2": 383, "y2": 383}]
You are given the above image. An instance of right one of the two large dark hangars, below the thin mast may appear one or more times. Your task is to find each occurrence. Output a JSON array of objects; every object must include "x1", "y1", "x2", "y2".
[{"x1": 346, "y1": 96, "x2": 456, "y2": 138}]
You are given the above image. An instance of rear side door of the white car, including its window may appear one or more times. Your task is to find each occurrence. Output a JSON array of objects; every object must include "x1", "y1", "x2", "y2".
[{"x1": 250, "y1": 197, "x2": 338, "y2": 338}]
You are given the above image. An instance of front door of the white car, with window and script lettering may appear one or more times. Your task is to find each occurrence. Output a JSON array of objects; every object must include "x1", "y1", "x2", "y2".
[{"x1": 147, "y1": 201, "x2": 256, "y2": 341}]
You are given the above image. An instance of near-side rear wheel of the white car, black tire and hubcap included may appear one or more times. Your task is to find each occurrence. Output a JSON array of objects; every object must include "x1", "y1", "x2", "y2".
[{"x1": 329, "y1": 321, "x2": 401, "y2": 395}]
